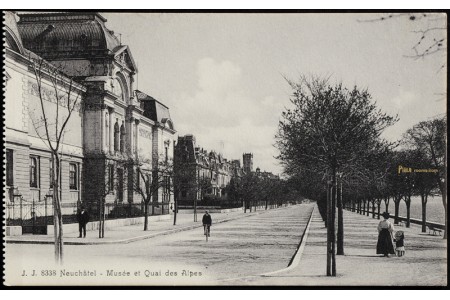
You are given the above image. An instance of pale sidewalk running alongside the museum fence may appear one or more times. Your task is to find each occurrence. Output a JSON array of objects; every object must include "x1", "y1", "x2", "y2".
[{"x1": 5, "y1": 210, "x2": 270, "y2": 245}]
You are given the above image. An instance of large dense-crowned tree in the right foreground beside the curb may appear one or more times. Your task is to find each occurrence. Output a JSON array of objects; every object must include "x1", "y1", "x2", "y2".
[{"x1": 276, "y1": 77, "x2": 397, "y2": 276}]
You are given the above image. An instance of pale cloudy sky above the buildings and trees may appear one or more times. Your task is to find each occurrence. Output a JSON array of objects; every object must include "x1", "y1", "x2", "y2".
[{"x1": 102, "y1": 13, "x2": 446, "y2": 174}]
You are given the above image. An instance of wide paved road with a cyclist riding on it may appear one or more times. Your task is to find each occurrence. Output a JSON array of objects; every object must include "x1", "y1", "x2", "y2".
[{"x1": 5, "y1": 204, "x2": 314, "y2": 285}]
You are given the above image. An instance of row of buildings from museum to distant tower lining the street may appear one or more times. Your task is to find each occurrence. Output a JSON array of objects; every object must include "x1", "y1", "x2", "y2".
[{"x1": 3, "y1": 11, "x2": 278, "y2": 227}]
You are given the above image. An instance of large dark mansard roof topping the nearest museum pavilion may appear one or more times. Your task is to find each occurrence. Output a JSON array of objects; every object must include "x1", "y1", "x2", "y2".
[{"x1": 18, "y1": 12, "x2": 120, "y2": 58}]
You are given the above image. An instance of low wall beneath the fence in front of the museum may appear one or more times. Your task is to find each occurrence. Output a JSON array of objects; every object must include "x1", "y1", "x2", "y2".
[{"x1": 6, "y1": 215, "x2": 172, "y2": 236}]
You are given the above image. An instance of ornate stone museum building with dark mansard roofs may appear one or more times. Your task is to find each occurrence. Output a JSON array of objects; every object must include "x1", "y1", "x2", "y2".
[{"x1": 5, "y1": 12, "x2": 176, "y2": 218}]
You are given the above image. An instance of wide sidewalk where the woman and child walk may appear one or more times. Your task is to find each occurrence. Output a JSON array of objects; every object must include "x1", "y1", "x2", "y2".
[{"x1": 223, "y1": 207, "x2": 447, "y2": 286}]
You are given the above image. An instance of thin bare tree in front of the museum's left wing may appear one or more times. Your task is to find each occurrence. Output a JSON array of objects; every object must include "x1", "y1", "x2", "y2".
[{"x1": 29, "y1": 54, "x2": 81, "y2": 264}]
